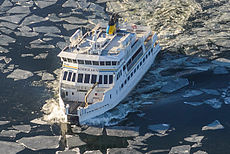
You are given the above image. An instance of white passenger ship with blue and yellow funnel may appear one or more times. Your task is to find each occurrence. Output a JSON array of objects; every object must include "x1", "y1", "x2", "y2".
[{"x1": 58, "y1": 14, "x2": 161, "y2": 125}]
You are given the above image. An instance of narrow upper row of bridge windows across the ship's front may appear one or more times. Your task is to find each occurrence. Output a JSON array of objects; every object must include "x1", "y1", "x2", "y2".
[{"x1": 62, "y1": 57, "x2": 120, "y2": 66}]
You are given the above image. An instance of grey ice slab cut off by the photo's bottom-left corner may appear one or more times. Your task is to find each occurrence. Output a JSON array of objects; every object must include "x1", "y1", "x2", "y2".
[{"x1": 0, "y1": 141, "x2": 25, "y2": 154}]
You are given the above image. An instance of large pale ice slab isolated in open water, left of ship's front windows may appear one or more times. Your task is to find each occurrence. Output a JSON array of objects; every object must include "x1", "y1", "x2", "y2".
[{"x1": 7, "y1": 69, "x2": 33, "y2": 81}]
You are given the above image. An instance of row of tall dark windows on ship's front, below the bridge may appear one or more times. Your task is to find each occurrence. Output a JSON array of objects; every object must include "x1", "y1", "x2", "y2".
[{"x1": 63, "y1": 71, "x2": 113, "y2": 84}]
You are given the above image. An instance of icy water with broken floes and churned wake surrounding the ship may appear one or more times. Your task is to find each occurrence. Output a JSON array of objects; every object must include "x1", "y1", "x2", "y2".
[{"x1": 0, "y1": 0, "x2": 230, "y2": 154}]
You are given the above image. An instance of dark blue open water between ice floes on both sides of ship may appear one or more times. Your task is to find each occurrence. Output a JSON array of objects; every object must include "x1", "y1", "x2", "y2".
[{"x1": 0, "y1": 0, "x2": 230, "y2": 154}]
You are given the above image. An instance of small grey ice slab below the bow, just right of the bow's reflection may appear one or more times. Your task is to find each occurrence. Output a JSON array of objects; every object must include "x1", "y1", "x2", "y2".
[{"x1": 66, "y1": 135, "x2": 86, "y2": 149}]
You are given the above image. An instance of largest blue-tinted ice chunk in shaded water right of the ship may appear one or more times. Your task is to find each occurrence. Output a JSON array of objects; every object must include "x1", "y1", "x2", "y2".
[{"x1": 160, "y1": 78, "x2": 189, "y2": 93}]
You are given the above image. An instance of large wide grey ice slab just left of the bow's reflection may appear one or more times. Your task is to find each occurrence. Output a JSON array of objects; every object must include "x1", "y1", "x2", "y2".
[{"x1": 17, "y1": 136, "x2": 61, "y2": 151}]
